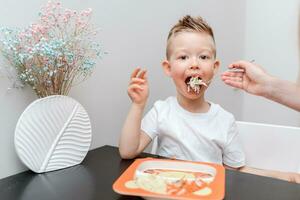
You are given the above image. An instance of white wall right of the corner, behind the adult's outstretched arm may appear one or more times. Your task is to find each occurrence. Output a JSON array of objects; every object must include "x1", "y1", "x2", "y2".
[{"x1": 242, "y1": 0, "x2": 300, "y2": 126}]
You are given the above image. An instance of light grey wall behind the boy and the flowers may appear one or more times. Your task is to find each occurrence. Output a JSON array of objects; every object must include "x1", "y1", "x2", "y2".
[{"x1": 0, "y1": 0, "x2": 245, "y2": 178}]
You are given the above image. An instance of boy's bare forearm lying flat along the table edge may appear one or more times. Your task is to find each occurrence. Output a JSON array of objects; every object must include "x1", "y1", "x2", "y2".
[{"x1": 224, "y1": 165, "x2": 300, "y2": 183}]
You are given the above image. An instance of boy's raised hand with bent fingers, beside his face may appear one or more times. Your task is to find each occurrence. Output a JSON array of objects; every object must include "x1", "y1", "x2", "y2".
[{"x1": 127, "y1": 67, "x2": 149, "y2": 106}]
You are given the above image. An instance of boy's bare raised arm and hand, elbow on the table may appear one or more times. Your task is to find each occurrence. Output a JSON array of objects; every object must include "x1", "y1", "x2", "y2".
[{"x1": 119, "y1": 68, "x2": 151, "y2": 159}]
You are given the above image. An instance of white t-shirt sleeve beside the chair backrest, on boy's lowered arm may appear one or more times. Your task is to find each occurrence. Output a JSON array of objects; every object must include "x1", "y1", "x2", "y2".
[{"x1": 223, "y1": 118, "x2": 245, "y2": 168}]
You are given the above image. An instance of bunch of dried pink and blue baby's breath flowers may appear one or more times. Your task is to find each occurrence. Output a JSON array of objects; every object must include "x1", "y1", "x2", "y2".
[{"x1": 0, "y1": 1, "x2": 102, "y2": 97}]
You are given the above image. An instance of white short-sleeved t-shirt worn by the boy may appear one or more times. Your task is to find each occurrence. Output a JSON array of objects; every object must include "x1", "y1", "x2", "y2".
[{"x1": 141, "y1": 97, "x2": 245, "y2": 168}]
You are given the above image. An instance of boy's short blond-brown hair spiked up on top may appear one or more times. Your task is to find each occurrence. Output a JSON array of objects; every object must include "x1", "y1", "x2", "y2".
[{"x1": 166, "y1": 15, "x2": 216, "y2": 59}]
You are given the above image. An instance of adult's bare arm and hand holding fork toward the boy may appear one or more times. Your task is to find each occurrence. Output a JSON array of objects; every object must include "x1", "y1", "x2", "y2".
[{"x1": 222, "y1": 61, "x2": 300, "y2": 111}]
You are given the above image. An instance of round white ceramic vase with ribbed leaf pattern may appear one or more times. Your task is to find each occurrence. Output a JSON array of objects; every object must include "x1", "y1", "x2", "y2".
[{"x1": 15, "y1": 95, "x2": 92, "y2": 173}]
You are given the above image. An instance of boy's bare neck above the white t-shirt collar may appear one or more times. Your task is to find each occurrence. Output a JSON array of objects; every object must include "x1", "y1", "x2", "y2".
[{"x1": 177, "y1": 94, "x2": 210, "y2": 113}]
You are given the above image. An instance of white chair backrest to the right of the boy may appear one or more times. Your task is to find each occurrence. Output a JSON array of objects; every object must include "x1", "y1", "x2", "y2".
[{"x1": 237, "y1": 121, "x2": 300, "y2": 173}]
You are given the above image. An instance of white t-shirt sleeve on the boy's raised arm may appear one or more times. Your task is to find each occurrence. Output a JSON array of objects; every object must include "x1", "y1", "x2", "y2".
[{"x1": 141, "y1": 104, "x2": 158, "y2": 139}]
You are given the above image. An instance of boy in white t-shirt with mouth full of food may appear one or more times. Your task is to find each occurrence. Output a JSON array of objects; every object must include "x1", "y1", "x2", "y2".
[{"x1": 119, "y1": 16, "x2": 300, "y2": 183}]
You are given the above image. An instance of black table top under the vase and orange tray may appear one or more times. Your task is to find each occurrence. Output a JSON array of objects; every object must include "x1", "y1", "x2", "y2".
[{"x1": 0, "y1": 146, "x2": 300, "y2": 200}]
